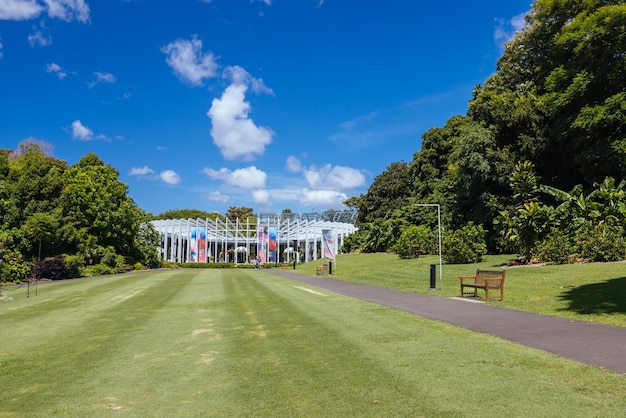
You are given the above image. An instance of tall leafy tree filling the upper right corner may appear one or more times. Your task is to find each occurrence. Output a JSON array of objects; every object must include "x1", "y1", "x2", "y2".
[{"x1": 469, "y1": 0, "x2": 626, "y2": 189}]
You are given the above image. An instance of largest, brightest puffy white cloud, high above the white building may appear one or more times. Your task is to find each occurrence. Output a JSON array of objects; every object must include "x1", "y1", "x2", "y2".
[{"x1": 207, "y1": 84, "x2": 274, "y2": 160}]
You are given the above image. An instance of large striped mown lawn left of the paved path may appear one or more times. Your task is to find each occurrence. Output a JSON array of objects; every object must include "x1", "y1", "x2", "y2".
[{"x1": 0, "y1": 270, "x2": 626, "y2": 417}]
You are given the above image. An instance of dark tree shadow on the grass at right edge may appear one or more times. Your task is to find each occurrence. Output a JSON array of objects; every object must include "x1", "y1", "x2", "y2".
[{"x1": 561, "y1": 277, "x2": 626, "y2": 314}]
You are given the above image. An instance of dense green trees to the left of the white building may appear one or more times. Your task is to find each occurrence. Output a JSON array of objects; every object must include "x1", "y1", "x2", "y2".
[{"x1": 0, "y1": 139, "x2": 158, "y2": 280}]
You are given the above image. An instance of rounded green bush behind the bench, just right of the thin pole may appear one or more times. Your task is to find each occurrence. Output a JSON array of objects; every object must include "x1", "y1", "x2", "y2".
[{"x1": 442, "y1": 222, "x2": 487, "y2": 264}]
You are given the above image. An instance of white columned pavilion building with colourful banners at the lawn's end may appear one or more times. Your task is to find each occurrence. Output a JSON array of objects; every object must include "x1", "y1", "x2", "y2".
[{"x1": 152, "y1": 211, "x2": 356, "y2": 264}]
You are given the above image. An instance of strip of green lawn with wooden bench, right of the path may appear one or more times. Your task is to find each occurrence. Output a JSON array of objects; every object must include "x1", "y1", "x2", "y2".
[{"x1": 297, "y1": 254, "x2": 626, "y2": 327}]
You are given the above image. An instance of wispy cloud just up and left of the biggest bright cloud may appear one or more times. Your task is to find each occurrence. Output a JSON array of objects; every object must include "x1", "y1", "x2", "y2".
[{"x1": 161, "y1": 36, "x2": 218, "y2": 86}]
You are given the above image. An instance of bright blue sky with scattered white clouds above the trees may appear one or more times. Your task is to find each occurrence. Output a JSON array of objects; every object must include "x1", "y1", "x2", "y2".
[{"x1": 0, "y1": 0, "x2": 530, "y2": 214}]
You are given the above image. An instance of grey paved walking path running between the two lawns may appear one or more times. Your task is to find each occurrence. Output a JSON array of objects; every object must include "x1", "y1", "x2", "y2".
[{"x1": 268, "y1": 270, "x2": 626, "y2": 373}]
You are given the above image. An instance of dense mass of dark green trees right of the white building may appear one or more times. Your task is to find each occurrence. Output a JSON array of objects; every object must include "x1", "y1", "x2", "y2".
[{"x1": 348, "y1": 0, "x2": 626, "y2": 258}]
